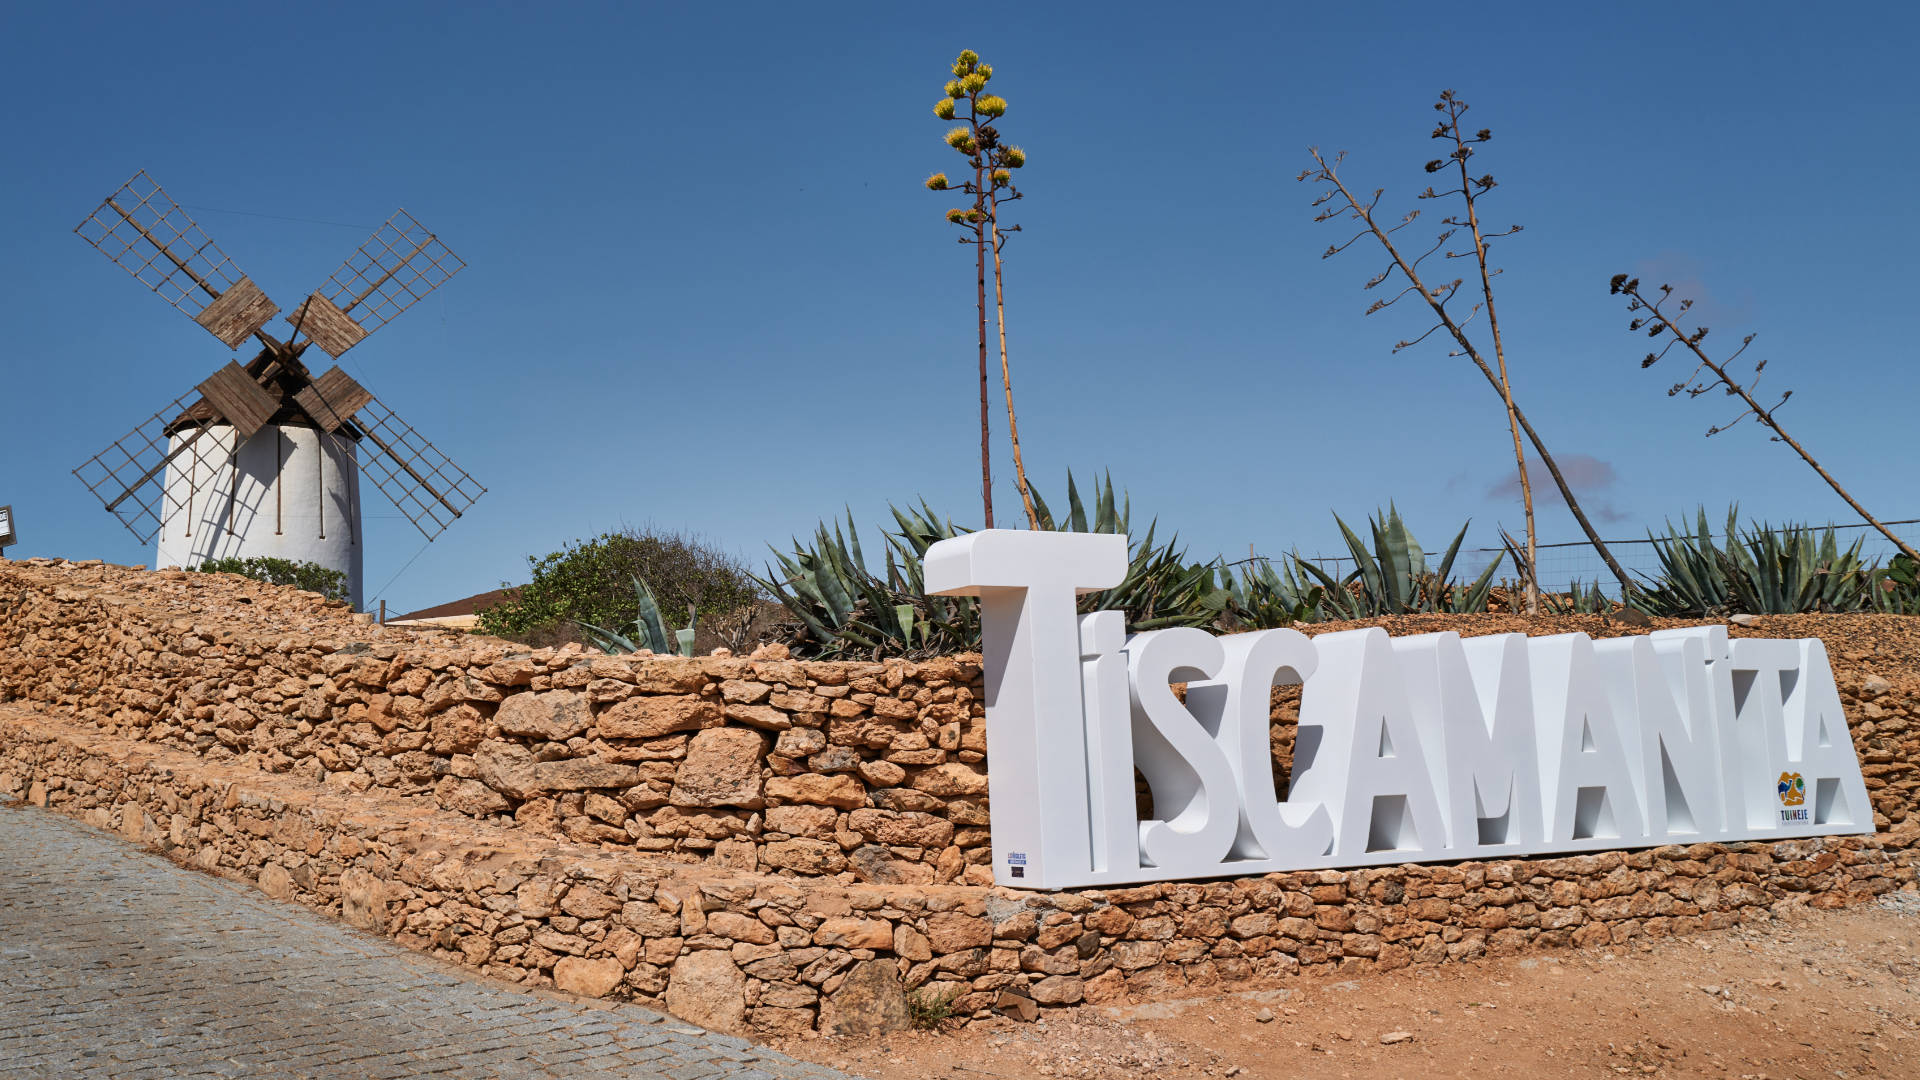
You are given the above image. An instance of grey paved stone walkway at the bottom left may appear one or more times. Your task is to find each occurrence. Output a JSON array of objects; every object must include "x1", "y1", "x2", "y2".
[{"x1": 0, "y1": 809, "x2": 843, "y2": 1080}]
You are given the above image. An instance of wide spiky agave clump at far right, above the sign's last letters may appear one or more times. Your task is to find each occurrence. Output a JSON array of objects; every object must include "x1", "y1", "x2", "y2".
[{"x1": 1632, "y1": 505, "x2": 1903, "y2": 615}]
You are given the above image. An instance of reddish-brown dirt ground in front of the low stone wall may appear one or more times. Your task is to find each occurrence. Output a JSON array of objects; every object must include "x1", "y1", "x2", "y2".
[{"x1": 781, "y1": 892, "x2": 1920, "y2": 1080}]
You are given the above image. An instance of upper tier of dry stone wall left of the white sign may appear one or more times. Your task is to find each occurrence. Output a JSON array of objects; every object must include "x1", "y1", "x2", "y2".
[{"x1": 0, "y1": 563, "x2": 993, "y2": 884}]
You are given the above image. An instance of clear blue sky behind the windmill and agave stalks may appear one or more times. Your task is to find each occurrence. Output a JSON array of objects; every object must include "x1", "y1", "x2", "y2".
[{"x1": 0, "y1": 4, "x2": 1920, "y2": 611}]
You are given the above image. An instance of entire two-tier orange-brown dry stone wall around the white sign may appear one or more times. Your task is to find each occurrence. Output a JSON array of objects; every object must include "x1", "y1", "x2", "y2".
[{"x1": 0, "y1": 563, "x2": 1920, "y2": 1034}]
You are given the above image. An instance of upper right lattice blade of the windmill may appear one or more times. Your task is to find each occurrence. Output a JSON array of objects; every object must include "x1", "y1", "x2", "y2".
[{"x1": 286, "y1": 209, "x2": 467, "y2": 357}]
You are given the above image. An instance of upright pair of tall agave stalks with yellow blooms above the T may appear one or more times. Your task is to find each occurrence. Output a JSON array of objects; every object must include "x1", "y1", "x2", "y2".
[{"x1": 927, "y1": 50, "x2": 1039, "y2": 528}]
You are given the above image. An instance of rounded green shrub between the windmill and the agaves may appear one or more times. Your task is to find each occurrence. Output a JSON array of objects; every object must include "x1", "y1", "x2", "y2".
[{"x1": 480, "y1": 528, "x2": 762, "y2": 640}]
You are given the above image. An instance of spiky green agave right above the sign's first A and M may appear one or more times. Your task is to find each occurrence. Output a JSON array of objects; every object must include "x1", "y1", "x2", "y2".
[{"x1": 1294, "y1": 503, "x2": 1500, "y2": 619}]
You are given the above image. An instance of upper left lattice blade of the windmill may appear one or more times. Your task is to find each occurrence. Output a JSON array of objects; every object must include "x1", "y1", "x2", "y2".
[{"x1": 73, "y1": 169, "x2": 280, "y2": 348}]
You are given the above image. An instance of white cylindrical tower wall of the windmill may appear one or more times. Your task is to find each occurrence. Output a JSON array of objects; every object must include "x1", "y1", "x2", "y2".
[{"x1": 154, "y1": 425, "x2": 361, "y2": 609}]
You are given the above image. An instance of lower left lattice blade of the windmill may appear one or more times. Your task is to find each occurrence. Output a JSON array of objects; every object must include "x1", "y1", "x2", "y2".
[{"x1": 73, "y1": 386, "x2": 238, "y2": 544}]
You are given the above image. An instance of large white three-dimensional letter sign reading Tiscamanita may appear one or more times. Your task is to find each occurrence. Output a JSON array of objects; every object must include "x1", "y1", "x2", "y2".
[{"x1": 925, "y1": 530, "x2": 1874, "y2": 890}]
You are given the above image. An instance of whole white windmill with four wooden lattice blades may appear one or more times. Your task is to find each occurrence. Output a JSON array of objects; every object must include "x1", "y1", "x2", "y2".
[{"x1": 73, "y1": 171, "x2": 486, "y2": 607}]
